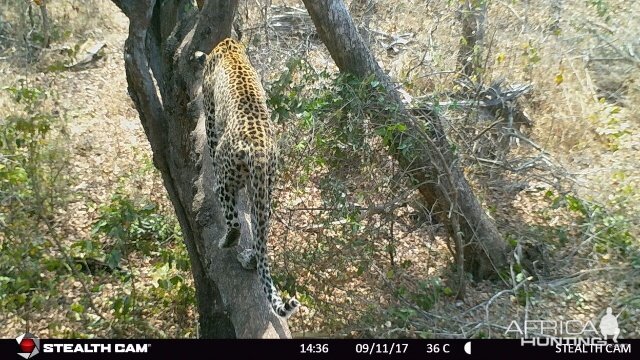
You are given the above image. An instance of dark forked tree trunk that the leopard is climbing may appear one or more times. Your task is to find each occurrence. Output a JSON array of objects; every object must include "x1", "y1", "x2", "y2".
[{"x1": 112, "y1": 0, "x2": 291, "y2": 338}]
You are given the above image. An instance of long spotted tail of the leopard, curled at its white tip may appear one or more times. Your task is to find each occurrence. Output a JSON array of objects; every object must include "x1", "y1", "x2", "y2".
[{"x1": 247, "y1": 152, "x2": 300, "y2": 318}]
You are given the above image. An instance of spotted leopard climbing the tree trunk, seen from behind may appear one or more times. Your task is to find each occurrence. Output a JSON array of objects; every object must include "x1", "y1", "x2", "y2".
[{"x1": 196, "y1": 38, "x2": 300, "y2": 318}]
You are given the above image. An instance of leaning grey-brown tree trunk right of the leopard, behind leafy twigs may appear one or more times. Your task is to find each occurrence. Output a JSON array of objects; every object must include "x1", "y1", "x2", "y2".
[{"x1": 303, "y1": 0, "x2": 507, "y2": 280}]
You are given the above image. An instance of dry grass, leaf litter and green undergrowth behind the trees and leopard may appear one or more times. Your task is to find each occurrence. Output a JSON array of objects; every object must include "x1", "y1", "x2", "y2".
[{"x1": 0, "y1": 0, "x2": 640, "y2": 338}]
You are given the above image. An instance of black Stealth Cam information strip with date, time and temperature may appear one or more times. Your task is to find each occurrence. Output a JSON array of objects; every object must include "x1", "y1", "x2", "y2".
[{"x1": 0, "y1": 334, "x2": 640, "y2": 360}]
